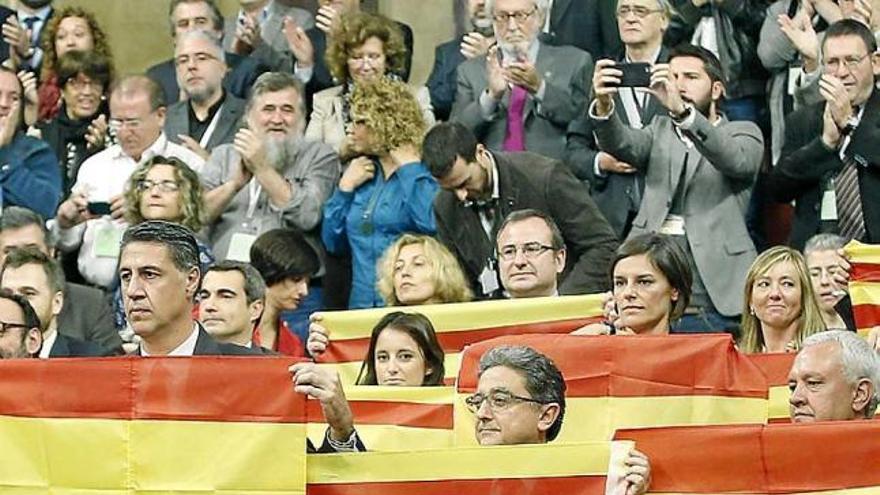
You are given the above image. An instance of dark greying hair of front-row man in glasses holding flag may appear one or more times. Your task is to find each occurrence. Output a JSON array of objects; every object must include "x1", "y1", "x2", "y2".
[{"x1": 479, "y1": 346, "x2": 566, "y2": 442}]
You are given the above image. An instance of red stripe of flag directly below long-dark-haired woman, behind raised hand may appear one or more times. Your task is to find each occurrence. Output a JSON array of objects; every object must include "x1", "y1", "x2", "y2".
[{"x1": 306, "y1": 399, "x2": 452, "y2": 430}]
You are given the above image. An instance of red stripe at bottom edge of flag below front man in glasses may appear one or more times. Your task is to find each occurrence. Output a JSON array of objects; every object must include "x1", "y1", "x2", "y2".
[{"x1": 306, "y1": 476, "x2": 605, "y2": 495}]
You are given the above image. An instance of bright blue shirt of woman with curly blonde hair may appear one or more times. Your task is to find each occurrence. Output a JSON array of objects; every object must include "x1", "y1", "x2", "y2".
[{"x1": 321, "y1": 162, "x2": 438, "y2": 308}]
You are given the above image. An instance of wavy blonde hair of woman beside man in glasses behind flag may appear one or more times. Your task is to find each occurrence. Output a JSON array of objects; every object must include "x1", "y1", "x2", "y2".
[{"x1": 376, "y1": 234, "x2": 474, "y2": 306}]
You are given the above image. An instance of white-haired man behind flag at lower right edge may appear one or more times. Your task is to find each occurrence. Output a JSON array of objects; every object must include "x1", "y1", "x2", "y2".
[{"x1": 788, "y1": 330, "x2": 880, "y2": 423}]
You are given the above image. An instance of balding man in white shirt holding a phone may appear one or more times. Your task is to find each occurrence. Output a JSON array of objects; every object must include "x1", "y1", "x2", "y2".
[{"x1": 55, "y1": 76, "x2": 204, "y2": 288}]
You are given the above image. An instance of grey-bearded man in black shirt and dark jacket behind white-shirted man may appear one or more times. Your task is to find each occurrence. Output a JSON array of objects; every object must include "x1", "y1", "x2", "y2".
[{"x1": 165, "y1": 30, "x2": 244, "y2": 159}]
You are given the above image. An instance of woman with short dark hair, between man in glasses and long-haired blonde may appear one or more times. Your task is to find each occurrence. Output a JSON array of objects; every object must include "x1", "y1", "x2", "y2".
[{"x1": 572, "y1": 234, "x2": 693, "y2": 335}]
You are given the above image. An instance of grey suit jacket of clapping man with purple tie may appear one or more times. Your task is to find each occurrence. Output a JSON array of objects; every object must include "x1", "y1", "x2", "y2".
[{"x1": 451, "y1": 44, "x2": 593, "y2": 159}]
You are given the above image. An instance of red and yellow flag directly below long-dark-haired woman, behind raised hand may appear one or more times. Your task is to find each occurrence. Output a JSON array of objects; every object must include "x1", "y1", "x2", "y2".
[{"x1": 307, "y1": 385, "x2": 455, "y2": 451}]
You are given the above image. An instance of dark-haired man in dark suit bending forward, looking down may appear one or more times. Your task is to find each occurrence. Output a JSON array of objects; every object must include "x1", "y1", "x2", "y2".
[{"x1": 422, "y1": 123, "x2": 617, "y2": 298}]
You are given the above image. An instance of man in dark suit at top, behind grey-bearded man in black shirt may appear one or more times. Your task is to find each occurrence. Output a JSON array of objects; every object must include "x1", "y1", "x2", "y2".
[{"x1": 147, "y1": 0, "x2": 269, "y2": 105}]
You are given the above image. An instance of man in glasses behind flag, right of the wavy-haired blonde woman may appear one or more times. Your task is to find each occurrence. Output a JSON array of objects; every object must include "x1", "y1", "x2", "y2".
[{"x1": 495, "y1": 210, "x2": 565, "y2": 299}]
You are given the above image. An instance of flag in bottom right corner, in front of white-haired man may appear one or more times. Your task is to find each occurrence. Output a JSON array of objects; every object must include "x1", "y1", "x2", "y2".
[{"x1": 615, "y1": 420, "x2": 880, "y2": 495}]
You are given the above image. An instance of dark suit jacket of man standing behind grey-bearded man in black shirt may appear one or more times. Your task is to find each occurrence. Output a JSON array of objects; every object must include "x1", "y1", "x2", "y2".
[{"x1": 147, "y1": 52, "x2": 269, "y2": 106}]
